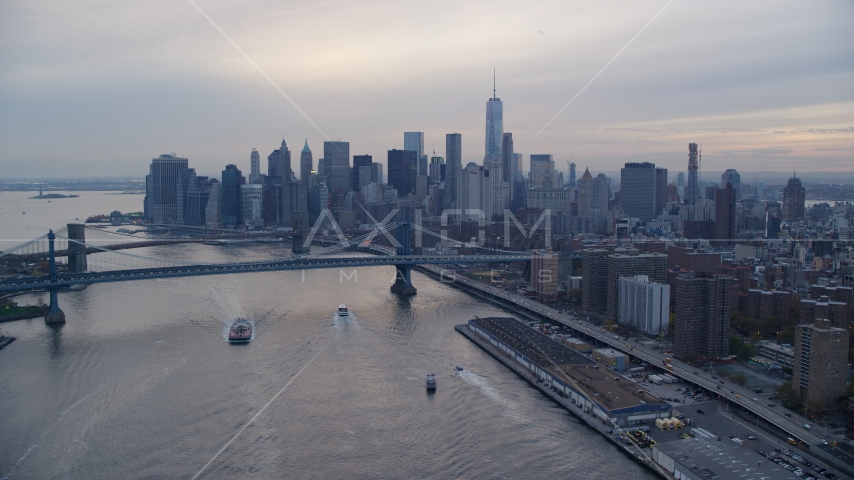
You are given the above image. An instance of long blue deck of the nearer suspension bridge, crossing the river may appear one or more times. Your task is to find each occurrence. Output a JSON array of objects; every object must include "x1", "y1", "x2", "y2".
[{"x1": 0, "y1": 253, "x2": 531, "y2": 292}]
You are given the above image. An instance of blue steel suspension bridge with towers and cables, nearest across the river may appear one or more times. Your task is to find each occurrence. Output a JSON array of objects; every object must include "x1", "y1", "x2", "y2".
[{"x1": 0, "y1": 217, "x2": 556, "y2": 323}]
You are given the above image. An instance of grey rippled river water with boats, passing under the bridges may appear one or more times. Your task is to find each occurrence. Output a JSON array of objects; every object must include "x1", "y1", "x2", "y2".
[{"x1": 0, "y1": 192, "x2": 657, "y2": 480}]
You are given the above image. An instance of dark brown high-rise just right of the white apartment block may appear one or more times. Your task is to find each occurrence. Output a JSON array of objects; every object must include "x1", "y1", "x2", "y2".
[{"x1": 673, "y1": 273, "x2": 735, "y2": 361}]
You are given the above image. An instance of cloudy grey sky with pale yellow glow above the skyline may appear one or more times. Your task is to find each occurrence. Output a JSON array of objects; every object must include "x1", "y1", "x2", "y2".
[{"x1": 0, "y1": 0, "x2": 854, "y2": 178}]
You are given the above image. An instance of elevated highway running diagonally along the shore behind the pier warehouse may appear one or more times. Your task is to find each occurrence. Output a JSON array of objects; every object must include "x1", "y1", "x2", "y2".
[{"x1": 424, "y1": 265, "x2": 822, "y2": 445}]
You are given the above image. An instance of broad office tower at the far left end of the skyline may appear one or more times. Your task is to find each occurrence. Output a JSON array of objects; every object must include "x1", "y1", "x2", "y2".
[{"x1": 145, "y1": 155, "x2": 187, "y2": 223}]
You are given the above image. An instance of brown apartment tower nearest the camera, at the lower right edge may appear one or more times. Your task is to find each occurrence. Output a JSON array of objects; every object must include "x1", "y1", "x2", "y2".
[{"x1": 792, "y1": 319, "x2": 848, "y2": 414}]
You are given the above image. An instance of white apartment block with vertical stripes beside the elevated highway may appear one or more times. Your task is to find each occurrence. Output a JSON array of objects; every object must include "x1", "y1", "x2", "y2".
[{"x1": 617, "y1": 275, "x2": 670, "y2": 335}]
